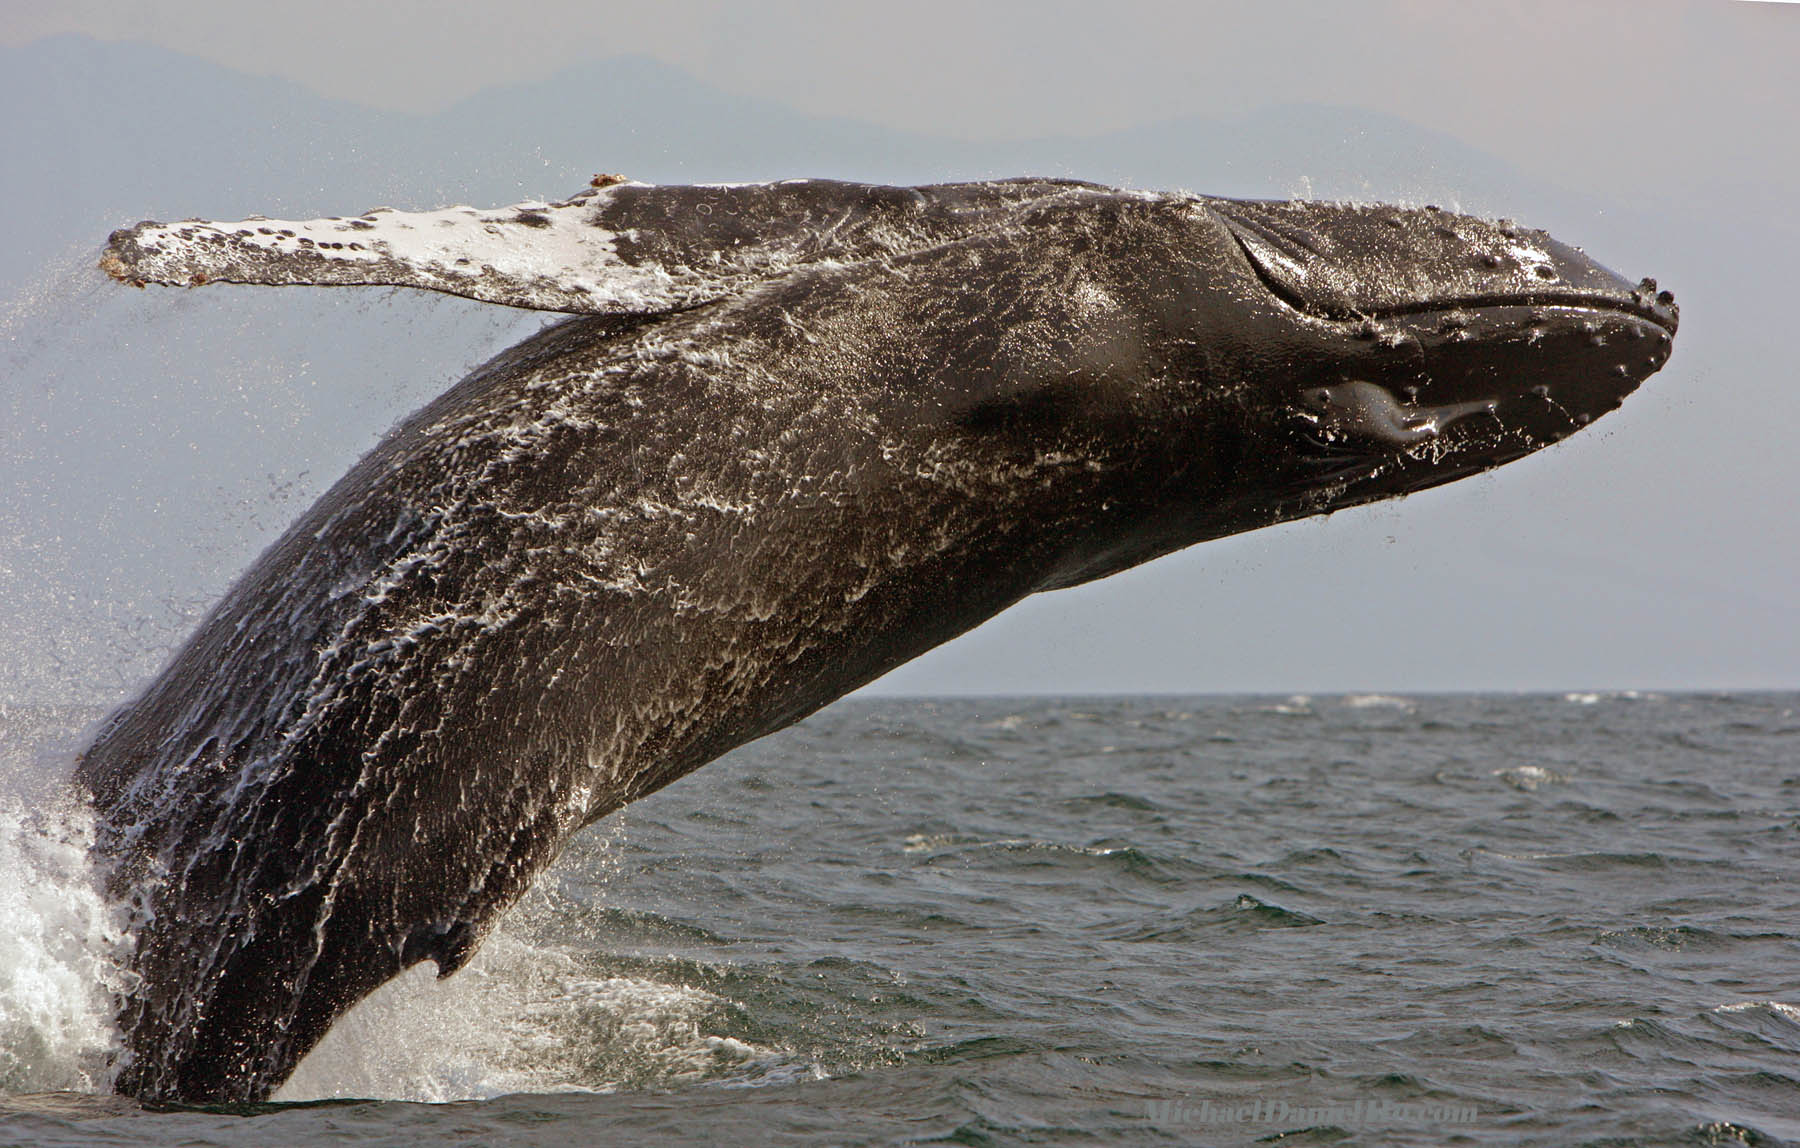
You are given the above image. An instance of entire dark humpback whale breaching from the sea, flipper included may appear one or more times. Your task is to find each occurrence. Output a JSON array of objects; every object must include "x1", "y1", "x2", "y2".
[{"x1": 77, "y1": 176, "x2": 1676, "y2": 1101}]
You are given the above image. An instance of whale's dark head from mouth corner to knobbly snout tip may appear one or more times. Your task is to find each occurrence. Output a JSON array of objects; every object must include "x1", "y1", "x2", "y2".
[{"x1": 1204, "y1": 200, "x2": 1676, "y2": 518}]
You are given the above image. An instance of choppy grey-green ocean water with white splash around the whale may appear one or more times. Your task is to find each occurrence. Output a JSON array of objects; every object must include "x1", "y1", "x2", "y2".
[{"x1": 0, "y1": 693, "x2": 1800, "y2": 1146}]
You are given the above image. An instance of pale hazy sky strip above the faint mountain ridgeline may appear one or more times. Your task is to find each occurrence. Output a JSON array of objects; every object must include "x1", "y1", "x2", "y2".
[{"x1": 14, "y1": 0, "x2": 1800, "y2": 206}]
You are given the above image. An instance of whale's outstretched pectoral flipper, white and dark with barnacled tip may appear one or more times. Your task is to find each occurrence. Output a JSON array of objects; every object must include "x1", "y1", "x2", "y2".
[{"x1": 101, "y1": 180, "x2": 1118, "y2": 315}]
